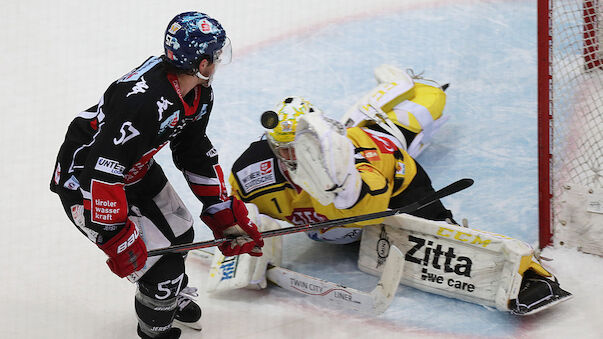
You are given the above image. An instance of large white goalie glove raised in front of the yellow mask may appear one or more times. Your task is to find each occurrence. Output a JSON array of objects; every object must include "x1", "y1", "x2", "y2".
[{"x1": 291, "y1": 112, "x2": 362, "y2": 209}]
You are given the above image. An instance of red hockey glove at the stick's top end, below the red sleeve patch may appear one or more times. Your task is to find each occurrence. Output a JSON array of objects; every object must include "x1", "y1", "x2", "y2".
[{"x1": 98, "y1": 219, "x2": 147, "y2": 278}]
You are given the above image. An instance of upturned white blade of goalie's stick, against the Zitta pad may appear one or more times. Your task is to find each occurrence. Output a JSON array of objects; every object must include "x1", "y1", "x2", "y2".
[{"x1": 371, "y1": 246, "x2": 404, "y2": 315}]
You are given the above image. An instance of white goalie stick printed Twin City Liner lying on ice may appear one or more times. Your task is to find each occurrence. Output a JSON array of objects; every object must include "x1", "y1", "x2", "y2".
[{"x1": 190, "y1": 246, "x2": 404, "y2": 316}]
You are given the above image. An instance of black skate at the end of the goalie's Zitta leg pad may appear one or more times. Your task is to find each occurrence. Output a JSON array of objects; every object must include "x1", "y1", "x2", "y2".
[{"x1": 509, "y1": 270, "x2": 572, "y2": 315}]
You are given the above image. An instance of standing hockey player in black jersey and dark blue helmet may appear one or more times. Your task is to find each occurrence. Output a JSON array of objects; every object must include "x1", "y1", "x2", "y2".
[{"x1": 50, "y1": 12, "x2": 263, "y2": 338}]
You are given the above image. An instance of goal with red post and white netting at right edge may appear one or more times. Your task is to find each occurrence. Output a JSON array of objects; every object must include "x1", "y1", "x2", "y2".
[{"x1": 538, "y1": 0, "x2": 603, "y2": 255}]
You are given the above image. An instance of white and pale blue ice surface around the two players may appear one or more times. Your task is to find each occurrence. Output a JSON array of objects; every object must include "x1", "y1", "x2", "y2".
[{"x1": 0, "y1": 0, "x2": 603, "y2": 339}]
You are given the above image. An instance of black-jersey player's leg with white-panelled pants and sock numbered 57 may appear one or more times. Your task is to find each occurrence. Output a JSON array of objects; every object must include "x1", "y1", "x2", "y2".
[{"x1": 127, "y1": 165, "x2": 201, "y2": 335}]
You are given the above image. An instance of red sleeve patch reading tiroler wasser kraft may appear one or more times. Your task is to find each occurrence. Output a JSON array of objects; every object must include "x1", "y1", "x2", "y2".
[{"x1": 90, "y1": 179, "x2": 128, "y2": 225}]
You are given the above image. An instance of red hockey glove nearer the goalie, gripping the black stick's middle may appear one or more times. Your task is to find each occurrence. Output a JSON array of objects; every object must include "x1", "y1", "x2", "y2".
[{"x1": 201, "y1": 196, "x2": 264, "y2": 257}]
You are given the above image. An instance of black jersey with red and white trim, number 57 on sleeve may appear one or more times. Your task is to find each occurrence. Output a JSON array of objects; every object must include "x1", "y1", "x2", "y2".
[{"x1": 50, "y1": 57, "x2": 226, "y2": 231}]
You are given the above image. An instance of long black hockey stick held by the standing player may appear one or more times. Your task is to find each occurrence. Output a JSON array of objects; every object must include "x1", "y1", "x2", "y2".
[{"x1": 148, "y1": 178, "x2": 473, "y2": 257}]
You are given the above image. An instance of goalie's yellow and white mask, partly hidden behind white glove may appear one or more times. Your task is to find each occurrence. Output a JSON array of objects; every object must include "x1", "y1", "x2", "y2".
[{"x1": 266, "y1": 97, "x2": 320, "y2": 171}]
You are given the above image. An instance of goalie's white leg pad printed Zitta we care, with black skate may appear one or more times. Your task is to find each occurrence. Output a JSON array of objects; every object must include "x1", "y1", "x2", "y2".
[{"x1": 358, "y1": 214, "x2": 572, "y2": 315}]
